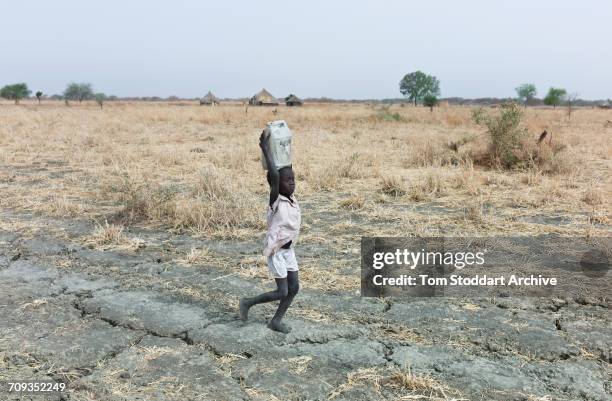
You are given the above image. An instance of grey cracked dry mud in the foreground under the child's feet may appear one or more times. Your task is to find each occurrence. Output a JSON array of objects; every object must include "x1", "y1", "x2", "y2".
[{"x1": 0, "y1": 213, "x2": 612, "y2": 401}]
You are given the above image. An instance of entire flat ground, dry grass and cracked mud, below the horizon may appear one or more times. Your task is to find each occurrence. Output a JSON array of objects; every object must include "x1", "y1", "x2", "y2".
[{"x1": 0, "y1": 103, "x2": 612, "y2": 401}]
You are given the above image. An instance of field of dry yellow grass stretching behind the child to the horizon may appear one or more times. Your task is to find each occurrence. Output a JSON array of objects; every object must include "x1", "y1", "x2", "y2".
[{"x1": 0, "y1": 102, "x2": 612, "y2": 247}]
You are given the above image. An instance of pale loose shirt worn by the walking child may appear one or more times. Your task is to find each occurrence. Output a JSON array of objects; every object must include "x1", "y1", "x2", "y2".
[{"x1": 263, "y1": 194, "x2": 302, "y2": 256}]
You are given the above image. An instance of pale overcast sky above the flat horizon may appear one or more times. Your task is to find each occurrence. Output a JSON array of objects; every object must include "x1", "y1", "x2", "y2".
[{"x1": 0, "y1": 0, "x2": 612, "y2": 99}]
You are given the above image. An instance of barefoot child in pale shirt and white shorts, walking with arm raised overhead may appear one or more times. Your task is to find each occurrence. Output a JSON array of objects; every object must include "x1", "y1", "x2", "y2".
[{"x1": 239, "y1": 133, "x2": 301, "y2": 334}]
